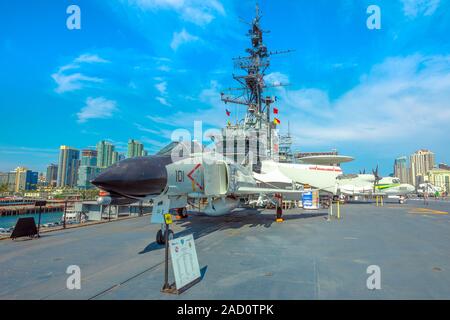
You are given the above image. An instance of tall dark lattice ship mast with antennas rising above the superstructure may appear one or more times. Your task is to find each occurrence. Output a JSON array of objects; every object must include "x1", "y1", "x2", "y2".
[{"x1": 219, "y1": 3, "x2": 291, "y2": 172}]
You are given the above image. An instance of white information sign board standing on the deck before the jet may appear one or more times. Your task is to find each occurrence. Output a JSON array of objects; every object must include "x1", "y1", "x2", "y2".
[{"x1": 169, "y1": 234, "x2": 200, "y2": 290}]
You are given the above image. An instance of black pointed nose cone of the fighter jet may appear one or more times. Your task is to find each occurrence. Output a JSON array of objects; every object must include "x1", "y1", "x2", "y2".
[{"x1": 92, "y1": 156, "x2": 172, "y2": 197}]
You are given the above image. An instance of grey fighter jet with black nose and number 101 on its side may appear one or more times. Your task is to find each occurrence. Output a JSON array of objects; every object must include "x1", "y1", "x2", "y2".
[{"x1": 92, "y1": 143, "x2": 301, "y2": 244}]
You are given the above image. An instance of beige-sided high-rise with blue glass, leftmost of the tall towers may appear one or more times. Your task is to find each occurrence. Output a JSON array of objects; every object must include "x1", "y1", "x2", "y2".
[{"x1": 57, "y1": 146, "x2": 80, "y2": 188}]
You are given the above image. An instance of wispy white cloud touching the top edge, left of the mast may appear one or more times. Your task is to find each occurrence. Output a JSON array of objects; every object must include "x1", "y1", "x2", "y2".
[{"x1": 128, "y1": 0, "x2": 225, "y2": 26}]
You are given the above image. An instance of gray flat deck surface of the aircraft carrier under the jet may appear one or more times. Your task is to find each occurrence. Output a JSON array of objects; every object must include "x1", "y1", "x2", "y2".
[{"x1": 0, "y1": 200, "x2": 450, "y2": 300}]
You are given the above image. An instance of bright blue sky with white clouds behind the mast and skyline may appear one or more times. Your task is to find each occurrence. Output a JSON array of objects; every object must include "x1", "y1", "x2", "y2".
[{"x1": 0, "y1": 0, "x2": 450, "y2": 175}]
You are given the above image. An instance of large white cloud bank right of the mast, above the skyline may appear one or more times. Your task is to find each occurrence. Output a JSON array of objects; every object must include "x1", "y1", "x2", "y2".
[{"x1": 279, "y1": 55, "x2": 450, "y2": 146}]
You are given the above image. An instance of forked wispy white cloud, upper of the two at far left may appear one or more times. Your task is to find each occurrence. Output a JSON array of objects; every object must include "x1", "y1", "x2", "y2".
[{"x1": 51, "y1": 53, "x2": 109, "y2": 93}]
